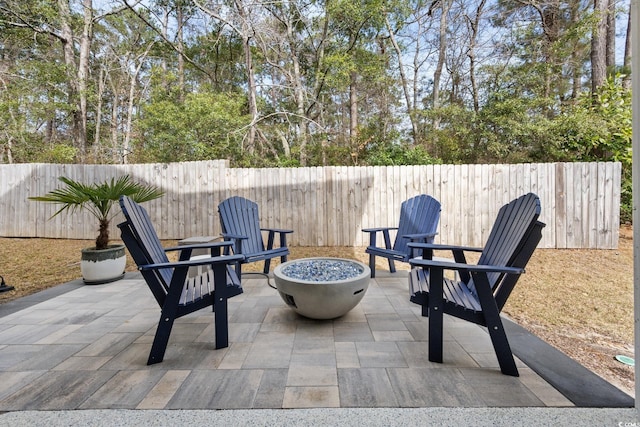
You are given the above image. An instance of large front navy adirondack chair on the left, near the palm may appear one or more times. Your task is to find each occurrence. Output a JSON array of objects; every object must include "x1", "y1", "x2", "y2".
[{"x1": 118, "y1": 196, "x2": 242, "y2": 365}]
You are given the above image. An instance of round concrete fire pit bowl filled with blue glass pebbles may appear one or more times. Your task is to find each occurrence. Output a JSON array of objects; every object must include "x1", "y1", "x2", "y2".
[{"x1": 273, "y1": 258, "x2": 371, "y2": 319}]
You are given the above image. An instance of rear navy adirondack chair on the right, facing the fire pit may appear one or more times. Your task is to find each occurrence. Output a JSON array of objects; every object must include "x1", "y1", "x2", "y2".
[{"x1": 362, "y1": 194, "x2": 440, "y2": 277}]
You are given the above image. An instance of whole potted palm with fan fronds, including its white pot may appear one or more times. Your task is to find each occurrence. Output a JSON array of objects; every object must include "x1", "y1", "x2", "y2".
[{"x1": 29, "y1": 175, "x2": 164, "y2": 284}]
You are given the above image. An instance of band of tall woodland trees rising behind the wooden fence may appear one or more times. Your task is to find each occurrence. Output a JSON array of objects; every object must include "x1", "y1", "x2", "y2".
[{"x1": 0, "y1": 0, "x2": 624, "y2": 177}]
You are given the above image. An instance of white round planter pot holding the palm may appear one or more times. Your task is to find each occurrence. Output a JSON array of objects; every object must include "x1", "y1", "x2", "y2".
[{"x1": 80, "y1": 245, "x2": 127, "y2": 285}]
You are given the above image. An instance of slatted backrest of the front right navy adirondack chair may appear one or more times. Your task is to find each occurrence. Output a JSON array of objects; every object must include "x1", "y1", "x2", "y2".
[{"x1": 467, "y1": 193, "x2": 541, "y2": 294}]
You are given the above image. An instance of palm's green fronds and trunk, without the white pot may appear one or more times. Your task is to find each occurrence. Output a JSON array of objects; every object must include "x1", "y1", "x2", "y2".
[{"x1": 29, "y1": 175, "x2": 164, "y2": 249}]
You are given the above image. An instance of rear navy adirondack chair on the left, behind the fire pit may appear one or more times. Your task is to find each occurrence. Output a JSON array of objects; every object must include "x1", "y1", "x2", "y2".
[{"x1": 218, "y1": 196, "x2": 293, "y2": 275}]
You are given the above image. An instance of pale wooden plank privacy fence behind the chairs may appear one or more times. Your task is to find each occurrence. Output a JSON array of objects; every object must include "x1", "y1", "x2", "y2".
[{"x1": 0, "y1": 160, "x2": 621, "y2": 249}]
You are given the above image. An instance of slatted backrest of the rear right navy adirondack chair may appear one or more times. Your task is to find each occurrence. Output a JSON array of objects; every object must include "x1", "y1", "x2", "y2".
[{"x1": 393, "y1": 194, "x2": 440, "y2": 254}]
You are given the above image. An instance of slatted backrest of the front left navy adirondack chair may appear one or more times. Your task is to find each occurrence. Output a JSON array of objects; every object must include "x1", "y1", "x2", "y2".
[{"x1": 119, "y1": 196, "x2": 173, "y2": 294}]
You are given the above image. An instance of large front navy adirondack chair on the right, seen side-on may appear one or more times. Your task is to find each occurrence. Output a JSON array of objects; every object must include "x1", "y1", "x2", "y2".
[{"x1": 409, "y1": 193, "x2": 545, "y2": 376}]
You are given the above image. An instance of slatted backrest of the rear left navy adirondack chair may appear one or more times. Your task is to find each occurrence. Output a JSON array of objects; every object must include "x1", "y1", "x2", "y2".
[{"x1": 218, "y1": 196, "x2": 265, "y2": 253}]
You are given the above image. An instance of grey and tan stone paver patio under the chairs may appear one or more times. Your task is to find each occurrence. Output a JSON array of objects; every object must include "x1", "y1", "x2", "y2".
[{"x1": 0, "y1": 272, "x2": 635, "y2": 423}]
